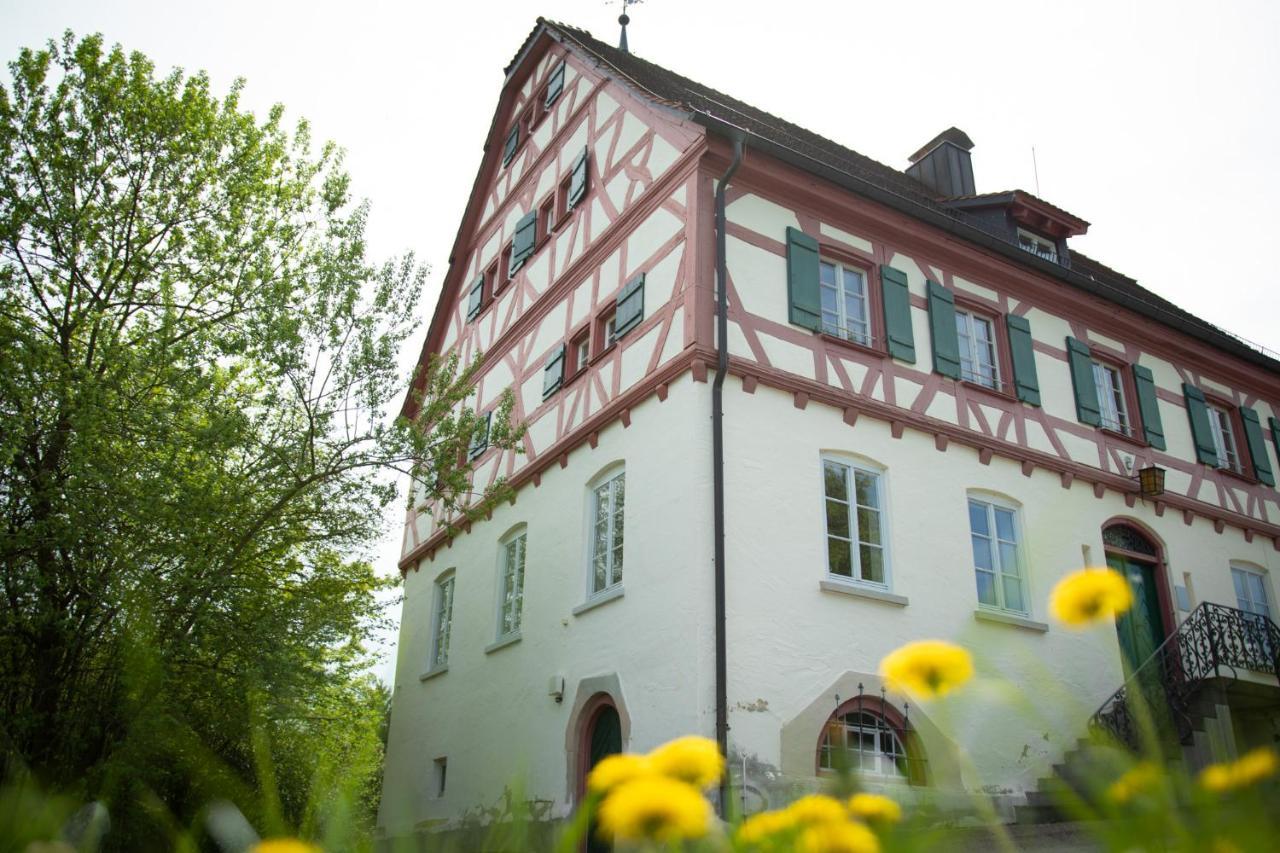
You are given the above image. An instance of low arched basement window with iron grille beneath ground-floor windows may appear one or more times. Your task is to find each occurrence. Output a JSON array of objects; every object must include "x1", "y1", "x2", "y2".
[{"x1": 818, "y1": 697, "x2": 924, "y2": 785}]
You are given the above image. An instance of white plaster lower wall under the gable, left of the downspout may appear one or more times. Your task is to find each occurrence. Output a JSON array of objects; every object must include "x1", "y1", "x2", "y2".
[{"x1": 379, "y1": 374, "x2": 714, "y2": 835}]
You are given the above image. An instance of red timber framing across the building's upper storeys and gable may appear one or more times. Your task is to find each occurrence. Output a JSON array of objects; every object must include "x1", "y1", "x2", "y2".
[{"x1": 399, "y1": 64, "x2": 1280, "y2": 563}]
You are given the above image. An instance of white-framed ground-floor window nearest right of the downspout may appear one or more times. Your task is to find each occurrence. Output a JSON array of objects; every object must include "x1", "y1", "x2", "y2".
[{"x1": 822, "y1": 459, "x2": 888, "y2": 585}]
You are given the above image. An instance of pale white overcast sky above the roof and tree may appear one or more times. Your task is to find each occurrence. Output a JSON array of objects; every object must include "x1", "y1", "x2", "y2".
[{"x1": 0, "y1": 0, "x2": 1280, "y2": 681}]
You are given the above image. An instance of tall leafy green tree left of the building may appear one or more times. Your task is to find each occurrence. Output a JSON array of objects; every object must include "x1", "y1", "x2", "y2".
[{"x1": 0, "y1": 33, "x2": 520, "y2": 845}]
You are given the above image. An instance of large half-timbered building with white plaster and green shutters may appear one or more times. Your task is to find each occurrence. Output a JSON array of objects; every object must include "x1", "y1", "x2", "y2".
[{"x1": 380, "y1": 19, "x2": 1280, "y2": 835}]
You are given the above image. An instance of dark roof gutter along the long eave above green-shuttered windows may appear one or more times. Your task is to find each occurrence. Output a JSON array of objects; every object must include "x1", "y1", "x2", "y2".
[{"x1": 690, "y1": 110, "x2": 1280, "y2": 373}]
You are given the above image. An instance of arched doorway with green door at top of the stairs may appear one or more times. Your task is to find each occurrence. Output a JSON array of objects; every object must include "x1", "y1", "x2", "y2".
[{"x1": 1102, "y1": 521, "x2": 1174, "y2": 672}]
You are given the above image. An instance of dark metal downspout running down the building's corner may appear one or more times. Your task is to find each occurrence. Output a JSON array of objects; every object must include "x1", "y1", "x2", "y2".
[{"x1": 712, "y1": 133, "x2": 742, "y2": 816}]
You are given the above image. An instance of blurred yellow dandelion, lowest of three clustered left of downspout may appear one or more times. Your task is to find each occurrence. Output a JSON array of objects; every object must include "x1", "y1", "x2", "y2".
[{"x1": 600, "y1": 776, "x2": 712, "y2": 843}]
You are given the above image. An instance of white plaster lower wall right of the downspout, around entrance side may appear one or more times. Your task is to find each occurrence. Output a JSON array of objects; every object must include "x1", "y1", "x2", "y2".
[{"x1": 726, "y1": 384, "x2": 1280, "y2": 793}]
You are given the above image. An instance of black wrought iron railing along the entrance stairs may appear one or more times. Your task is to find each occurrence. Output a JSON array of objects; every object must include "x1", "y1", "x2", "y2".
[{"x1": 1089, "y1": 602, "x2": 1280, "y2": 749}]
